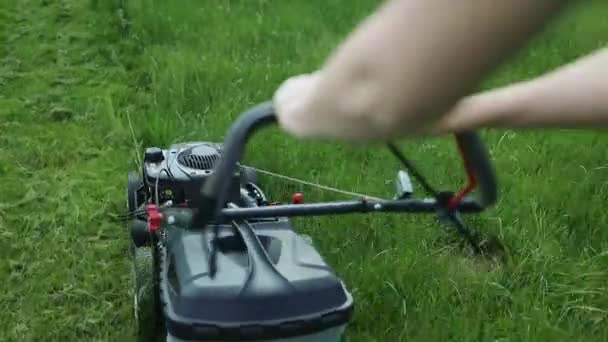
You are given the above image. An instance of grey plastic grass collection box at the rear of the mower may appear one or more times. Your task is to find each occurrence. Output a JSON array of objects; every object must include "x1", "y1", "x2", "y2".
[{"x1": 160, "y1": 219, "x2": 353, "y2": 341}]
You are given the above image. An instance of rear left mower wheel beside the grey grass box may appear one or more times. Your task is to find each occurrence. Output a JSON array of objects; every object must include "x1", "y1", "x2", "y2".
[{"x1": 132, "y1": 247, "x2": 162, "y2": 342}]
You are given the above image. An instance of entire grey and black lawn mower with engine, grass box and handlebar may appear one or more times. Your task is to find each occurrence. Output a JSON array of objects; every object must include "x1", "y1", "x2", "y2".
[{"x1": 127, "y1": 102, "x2": 497, "y2": 342}]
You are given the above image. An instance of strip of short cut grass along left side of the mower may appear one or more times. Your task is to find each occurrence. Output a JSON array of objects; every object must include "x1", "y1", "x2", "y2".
[{"x1": 0, "y1": 0, "x2": 137, "y2": 341}]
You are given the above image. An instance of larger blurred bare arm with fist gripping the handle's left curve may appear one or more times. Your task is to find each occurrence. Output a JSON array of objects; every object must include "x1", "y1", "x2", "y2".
[{"x1": 275, "y1": 0, "x2": 565, "y2": 140}]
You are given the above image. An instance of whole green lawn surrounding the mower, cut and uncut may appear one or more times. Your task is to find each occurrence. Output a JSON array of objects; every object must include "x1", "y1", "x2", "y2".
[{"x1": 0, "y1": 0, "x2": 608, "y2": 341}]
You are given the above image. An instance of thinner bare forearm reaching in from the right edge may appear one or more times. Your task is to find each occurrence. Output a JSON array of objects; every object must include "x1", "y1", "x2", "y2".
[{"x1": 436, "y1": 48, "x2": 608, "y2": 133}]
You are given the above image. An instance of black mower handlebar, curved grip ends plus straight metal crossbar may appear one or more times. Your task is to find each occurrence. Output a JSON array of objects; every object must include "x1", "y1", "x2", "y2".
[{"x1": 194, "y1": 101, "x2": 497, "y2": 226}]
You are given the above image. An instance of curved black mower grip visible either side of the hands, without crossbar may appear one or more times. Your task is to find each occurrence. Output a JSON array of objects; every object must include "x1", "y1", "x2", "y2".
[{"x1": 195, "y1": 101, "x2": 497, "y2": 226}]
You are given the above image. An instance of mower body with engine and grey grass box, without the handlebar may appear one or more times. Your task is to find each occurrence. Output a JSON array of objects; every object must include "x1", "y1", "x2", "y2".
[{"x1": 128, "y1": 142, "x2": 352, "y2": 342}]
